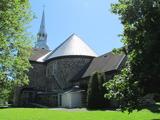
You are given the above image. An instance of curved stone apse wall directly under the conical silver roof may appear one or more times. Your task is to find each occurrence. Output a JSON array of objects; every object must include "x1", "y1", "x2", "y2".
[{"x1": 47, "y1": 56, "x2": 93, "y2": 89}]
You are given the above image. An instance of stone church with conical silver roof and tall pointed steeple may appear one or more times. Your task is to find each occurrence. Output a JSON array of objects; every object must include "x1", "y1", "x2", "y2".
[{"x1": 14, "y1": 11, "x2": 126, "y2": 108}]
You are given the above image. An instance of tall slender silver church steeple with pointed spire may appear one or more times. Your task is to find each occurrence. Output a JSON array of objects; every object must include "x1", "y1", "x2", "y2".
[{"x1": 35, "y1": 7, "x2": 49, "y2": 50}]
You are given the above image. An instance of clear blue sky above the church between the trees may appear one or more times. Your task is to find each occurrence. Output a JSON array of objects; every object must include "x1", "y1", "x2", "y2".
[{"x1": 30, "y1": 0, "x2": 122, "y2": 55}]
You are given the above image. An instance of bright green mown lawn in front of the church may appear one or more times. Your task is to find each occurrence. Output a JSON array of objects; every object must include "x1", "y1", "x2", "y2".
[{"x1": 0, "y1": 108, "x2": 160, "y2": 120}]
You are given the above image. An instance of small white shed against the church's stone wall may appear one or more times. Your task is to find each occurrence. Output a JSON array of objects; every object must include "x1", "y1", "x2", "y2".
[{"x1": 60, "y1": 90, "x2": 83, "y2": 108}]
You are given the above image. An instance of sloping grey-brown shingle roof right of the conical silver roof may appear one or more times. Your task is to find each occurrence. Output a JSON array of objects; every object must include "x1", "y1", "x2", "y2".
[{"x1": 82, "y1": 52, "x2": 125, "y2": 78}]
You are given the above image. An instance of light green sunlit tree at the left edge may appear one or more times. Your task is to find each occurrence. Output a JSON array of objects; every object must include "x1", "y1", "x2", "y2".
[{"x1": 0, "y1": 0, "x2": 32, "y2": 103}]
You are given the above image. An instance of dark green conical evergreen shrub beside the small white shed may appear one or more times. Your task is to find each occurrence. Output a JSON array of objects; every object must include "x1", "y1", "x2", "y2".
[{"x1": 87, "y1": 72, "x2": 106, "y2": 109}]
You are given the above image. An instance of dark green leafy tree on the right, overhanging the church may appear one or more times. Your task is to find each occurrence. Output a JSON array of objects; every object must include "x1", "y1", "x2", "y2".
[{"x1": 105, "y1": 0, "x2": 160, "y2": 111}]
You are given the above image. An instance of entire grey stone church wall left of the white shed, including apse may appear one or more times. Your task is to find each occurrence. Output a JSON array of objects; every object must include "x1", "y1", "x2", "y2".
[{"x1": 16, "y1": 56, "x2": 93, "y2": 107}]
